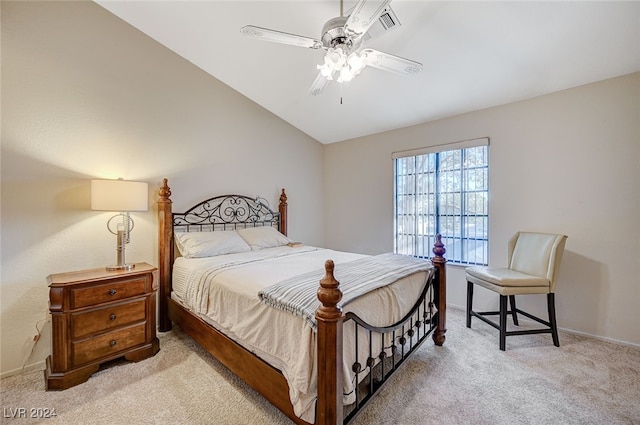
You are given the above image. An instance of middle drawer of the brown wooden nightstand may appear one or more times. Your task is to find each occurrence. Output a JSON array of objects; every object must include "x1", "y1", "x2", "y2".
[{"x1": 71, "y1": 298, "x2": 146, "y2": 339}]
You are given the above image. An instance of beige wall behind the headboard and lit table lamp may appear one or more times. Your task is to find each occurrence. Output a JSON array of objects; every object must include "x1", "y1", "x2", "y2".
[{"x1": 0, "y1": 1, "x2": 324, "y2": 375}]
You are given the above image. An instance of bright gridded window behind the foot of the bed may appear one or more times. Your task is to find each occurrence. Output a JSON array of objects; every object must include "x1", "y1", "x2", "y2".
[{"x1": 394, "y1": 139, "x2": 489, "y2": 265}]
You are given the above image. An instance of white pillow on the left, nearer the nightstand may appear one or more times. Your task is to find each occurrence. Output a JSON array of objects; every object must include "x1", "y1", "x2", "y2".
[{"x1": 175, "y1": 230, "x2": 251, "y2": 258}]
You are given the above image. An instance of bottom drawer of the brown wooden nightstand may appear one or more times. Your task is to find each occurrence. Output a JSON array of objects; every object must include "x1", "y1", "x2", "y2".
[{"x1": 71, "y1": 323, "x2": 146, "y2": 366}]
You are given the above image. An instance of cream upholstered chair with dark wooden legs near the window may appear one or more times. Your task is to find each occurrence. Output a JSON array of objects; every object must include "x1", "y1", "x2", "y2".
[{"x1": 466, "y1": 232, "x2": 567, "y2": 351}]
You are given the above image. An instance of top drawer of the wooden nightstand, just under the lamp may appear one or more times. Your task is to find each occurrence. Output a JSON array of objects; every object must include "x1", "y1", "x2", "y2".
[{"x1": 71, "y1": 276, "x2": 147, "y2": 308}]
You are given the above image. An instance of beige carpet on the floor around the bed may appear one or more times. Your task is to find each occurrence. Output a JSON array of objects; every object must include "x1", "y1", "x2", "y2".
[{"x1": 0, "y1": 309, "x2": 640, "y2": 425}]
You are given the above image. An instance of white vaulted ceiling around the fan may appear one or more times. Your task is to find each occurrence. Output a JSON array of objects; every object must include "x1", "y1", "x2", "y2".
[{"x1": 96, "y1": 0, "x2": 640, "y2": 143}]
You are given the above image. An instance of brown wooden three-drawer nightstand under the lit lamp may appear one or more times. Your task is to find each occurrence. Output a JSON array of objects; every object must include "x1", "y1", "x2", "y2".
[{"x1": 44, "y1": 263, "x2": 160, "y2": 390}]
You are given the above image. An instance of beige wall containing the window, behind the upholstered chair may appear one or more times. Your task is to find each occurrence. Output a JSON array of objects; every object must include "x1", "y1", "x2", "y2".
[{"x1": 324, "y1": 74, "x2": 640, "y2": 344}]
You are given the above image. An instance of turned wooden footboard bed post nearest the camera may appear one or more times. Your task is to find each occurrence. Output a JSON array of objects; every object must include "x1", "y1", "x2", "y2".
[{"x1": 316, "y1": 260, "x2": 344, "y2": 425}]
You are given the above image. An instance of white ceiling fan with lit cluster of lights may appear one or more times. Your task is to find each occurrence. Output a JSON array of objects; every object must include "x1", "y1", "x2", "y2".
[{"x1": 240, "y1": 0, "x2": 422, "y2": 95}]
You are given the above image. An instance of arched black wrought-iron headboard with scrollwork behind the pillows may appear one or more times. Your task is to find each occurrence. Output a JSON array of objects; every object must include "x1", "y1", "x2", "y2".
[{"x1": 173, "y1": 193, "x2": 286, "y2": 232}]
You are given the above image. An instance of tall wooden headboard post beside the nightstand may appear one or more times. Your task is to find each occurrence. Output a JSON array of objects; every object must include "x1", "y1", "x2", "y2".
[{"x1": 158, "y1": 179, "x2": 173, "y2": 332}]
